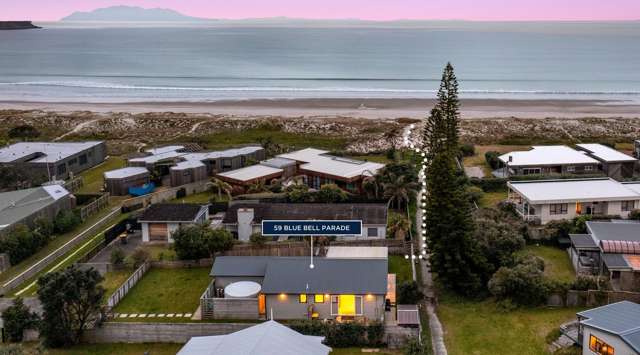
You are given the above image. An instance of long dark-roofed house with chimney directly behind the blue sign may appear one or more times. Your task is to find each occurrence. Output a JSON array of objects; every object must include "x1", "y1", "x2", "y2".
[{"x1": 222, "y1": 201, "x2": 387, "y2": 241}]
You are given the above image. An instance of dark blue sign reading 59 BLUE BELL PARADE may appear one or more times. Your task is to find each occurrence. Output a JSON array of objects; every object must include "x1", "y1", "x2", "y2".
[{"x1": 262, "y1": 220, "x2": 362, "y2": 236}]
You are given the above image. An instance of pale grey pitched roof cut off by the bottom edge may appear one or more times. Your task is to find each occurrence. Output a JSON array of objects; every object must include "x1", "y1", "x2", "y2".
[{"x1": 178, "y1": 320, "x2": 331, "y2": 355}]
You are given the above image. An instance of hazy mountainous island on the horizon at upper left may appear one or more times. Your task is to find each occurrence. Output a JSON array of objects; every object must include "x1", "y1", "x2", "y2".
[{"x1": 61, "y1": 6, "x2": 204, "y2": 22}]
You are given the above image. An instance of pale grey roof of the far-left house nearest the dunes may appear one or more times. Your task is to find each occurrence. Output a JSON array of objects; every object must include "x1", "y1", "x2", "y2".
[{"x1": 0, "y1": 141, "x2": 103, "y2": 163}]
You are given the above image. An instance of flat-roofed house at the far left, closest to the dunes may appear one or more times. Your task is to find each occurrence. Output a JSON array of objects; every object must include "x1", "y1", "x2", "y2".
[{"x1": 0, "y1": 142, "x2": 107, "y2": 183}]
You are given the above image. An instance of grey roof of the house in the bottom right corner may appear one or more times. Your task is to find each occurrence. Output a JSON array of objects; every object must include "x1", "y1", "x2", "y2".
[{"x1": 577, "y1": 301, "x2": 640, "y2": 351}]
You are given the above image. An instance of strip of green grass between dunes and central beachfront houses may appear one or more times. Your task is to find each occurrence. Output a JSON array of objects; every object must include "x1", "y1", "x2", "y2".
[{"x1": 198, "y1": 126, "x2": 348, "y2": 150}]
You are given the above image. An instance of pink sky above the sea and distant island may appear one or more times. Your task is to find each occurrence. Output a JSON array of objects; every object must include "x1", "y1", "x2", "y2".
[{"x1": 0, "y1": 0, "x2": 640, "y2": 21}]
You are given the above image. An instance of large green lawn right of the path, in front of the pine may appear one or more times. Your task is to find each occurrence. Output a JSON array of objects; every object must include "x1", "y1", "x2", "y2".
[{"x1": 438, "y1": 295, "x2": 580, "y2": 355}]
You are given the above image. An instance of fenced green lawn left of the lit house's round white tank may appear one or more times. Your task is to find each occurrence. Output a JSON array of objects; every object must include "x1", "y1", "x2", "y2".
[{"x1": 114, "y1": 268, "x2": 211, "y2": 313}]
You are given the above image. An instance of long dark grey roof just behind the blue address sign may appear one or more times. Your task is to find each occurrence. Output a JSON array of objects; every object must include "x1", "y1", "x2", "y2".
[{"x1": 223, "y1": 203, "x2": 387, "y2": 225}]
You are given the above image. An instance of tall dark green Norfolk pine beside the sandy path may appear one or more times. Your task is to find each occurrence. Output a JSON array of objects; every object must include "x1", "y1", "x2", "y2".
[{"x1": 424, "y1": 65, "x2": 486, "y2": 295}]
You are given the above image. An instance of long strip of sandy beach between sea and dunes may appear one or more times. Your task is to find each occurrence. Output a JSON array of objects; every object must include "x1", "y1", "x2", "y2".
[{"x1": 0, "y1": 99, "x2": 640, "y2": 119}]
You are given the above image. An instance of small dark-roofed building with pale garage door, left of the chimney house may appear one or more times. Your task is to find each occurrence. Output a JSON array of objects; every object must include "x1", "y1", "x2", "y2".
[{"x1": 138, "y1": 203, "x2": 209, "y2": 243}]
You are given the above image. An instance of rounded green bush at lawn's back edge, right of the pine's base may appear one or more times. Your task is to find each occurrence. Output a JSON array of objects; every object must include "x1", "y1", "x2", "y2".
[{"x1": 488, "y1": 257, "x2": 549, "y2": 306}]
